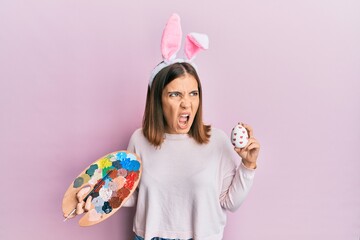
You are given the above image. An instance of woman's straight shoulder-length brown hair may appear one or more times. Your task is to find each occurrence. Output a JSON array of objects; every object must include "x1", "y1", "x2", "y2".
[{"x1": 142, "y1": 62, "x2": 211, "y2": 147}]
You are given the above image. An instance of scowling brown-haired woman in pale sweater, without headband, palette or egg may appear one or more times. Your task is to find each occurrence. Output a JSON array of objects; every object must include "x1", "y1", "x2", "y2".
[{"x1": 125, "y1": 62, "x2": 260, "y2": 240}]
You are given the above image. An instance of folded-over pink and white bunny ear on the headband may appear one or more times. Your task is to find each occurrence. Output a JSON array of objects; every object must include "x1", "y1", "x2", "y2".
[{"x1": 185, "y1": 33, "x2": 209, "y2": 60}]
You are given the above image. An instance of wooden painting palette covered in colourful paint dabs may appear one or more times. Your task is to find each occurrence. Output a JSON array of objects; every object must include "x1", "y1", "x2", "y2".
[{"x1": 62, "y1": 151, "x2": 142, "y2": 226}]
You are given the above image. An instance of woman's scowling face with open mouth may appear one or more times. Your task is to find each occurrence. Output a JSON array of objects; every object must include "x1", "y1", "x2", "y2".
[{"x1": 161, "y1": 74, "x2": 199, "y2": 134}]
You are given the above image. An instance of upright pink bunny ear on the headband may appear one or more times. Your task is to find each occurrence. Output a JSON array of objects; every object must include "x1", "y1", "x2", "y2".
[{"x1": 161, "y1": 13, "x2": 182, "y2": 61}]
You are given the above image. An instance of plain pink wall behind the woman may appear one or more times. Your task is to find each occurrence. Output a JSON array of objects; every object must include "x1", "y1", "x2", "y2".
[{"x1": 0, "y1": 0, "x2": 360, "y2": 240}]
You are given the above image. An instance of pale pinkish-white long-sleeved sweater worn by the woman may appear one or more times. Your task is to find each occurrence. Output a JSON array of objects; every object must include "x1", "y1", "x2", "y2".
[{"x1": 124, "y1": 128, "x2": 255, "y2": 240}]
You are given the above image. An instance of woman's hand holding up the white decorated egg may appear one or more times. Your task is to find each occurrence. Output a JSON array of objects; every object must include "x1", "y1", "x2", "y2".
[{"x1": 235, "y1": 123, "x2": 260, "y2": 169}]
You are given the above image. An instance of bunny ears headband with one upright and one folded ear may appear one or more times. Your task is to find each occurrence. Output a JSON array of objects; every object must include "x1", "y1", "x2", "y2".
[{"x1": 149, "y1": 13, "x2": 209, "y2": 86}]
